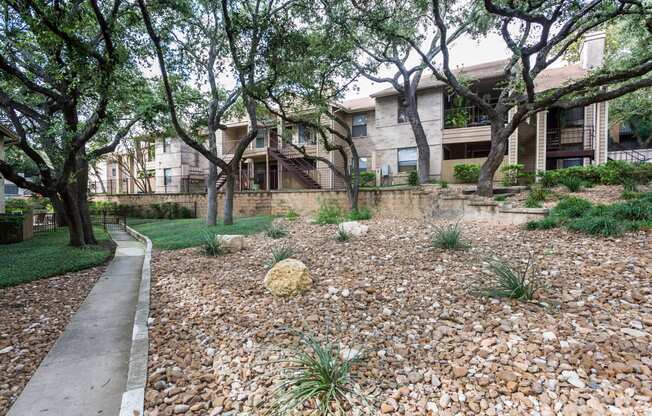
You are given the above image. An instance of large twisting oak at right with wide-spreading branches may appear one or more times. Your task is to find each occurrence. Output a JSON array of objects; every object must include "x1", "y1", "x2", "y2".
[{"x1": 408, "y1": 0, "x2": 652, "y2": 196}]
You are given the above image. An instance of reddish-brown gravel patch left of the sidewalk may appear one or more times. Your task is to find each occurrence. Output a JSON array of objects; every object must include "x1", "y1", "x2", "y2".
[{"x1": 0, "y1": 266, "x2": 105, "y2": 416}]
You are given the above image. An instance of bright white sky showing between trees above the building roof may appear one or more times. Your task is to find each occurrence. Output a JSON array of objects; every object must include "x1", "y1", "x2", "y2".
[{"x1": 346, "y1": 34, "x2": 510, "y2": 99}]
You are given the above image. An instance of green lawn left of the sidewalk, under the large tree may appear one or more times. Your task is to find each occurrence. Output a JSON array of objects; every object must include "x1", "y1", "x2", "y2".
[{"x1": 0, "y1": 228, "x2": 112, "y2": 287}]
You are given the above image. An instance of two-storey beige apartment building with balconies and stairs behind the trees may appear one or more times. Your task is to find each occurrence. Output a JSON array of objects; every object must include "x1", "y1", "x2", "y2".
[{"x1": 91, "y1": 32, "x2": 648, "y2": 193}]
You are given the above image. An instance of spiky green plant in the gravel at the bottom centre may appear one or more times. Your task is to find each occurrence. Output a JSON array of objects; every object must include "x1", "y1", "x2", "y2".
[{"x1": 265, "y1": 335, "x2": 368, "y2": 416}]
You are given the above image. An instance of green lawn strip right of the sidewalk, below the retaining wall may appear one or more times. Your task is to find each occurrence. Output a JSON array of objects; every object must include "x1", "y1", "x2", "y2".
[{"x1": 130, "y1": 216, "x2": 272, "y2": 250}]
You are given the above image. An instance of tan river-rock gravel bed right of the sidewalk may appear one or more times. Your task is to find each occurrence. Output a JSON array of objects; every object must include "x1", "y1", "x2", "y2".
[{"x1": 146, "y1": 219, "x2": 652, "y2": 416}]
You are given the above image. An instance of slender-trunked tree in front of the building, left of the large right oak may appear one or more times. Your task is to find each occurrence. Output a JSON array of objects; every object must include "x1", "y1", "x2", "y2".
[{"x1": 323, "y1": 0, "x2": 486, "y2": 183}]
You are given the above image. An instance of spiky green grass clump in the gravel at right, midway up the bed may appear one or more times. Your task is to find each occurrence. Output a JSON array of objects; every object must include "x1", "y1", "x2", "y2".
[{"x1": 472, "y1": 258, "x2": 543, "y2": 300}]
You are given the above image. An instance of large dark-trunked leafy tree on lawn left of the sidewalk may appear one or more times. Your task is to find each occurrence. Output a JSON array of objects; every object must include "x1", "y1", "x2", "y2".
[{"x1": 0, "y1": 0, "x2": 150, "y2": 246}]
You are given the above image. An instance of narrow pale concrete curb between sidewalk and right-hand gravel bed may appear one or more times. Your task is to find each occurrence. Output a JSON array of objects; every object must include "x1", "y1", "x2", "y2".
[{"x1": 120, "y1": 226, "x2": 152, "y2": 416}]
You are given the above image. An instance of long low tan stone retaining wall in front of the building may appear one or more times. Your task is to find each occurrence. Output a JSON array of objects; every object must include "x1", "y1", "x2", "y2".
[{"x1": 93, "y1": 186, "x2": 547, "y2": 224}]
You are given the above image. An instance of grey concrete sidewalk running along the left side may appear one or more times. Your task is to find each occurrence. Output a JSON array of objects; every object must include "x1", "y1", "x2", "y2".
[{"x1": 8, "y1": 231, "x2": 144, "y2": 416}]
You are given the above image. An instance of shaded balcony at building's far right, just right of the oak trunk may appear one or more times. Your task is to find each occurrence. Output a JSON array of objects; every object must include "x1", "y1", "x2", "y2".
[{"x1": 546, "y1": 126, "x2": 595, "y2": 159}]
